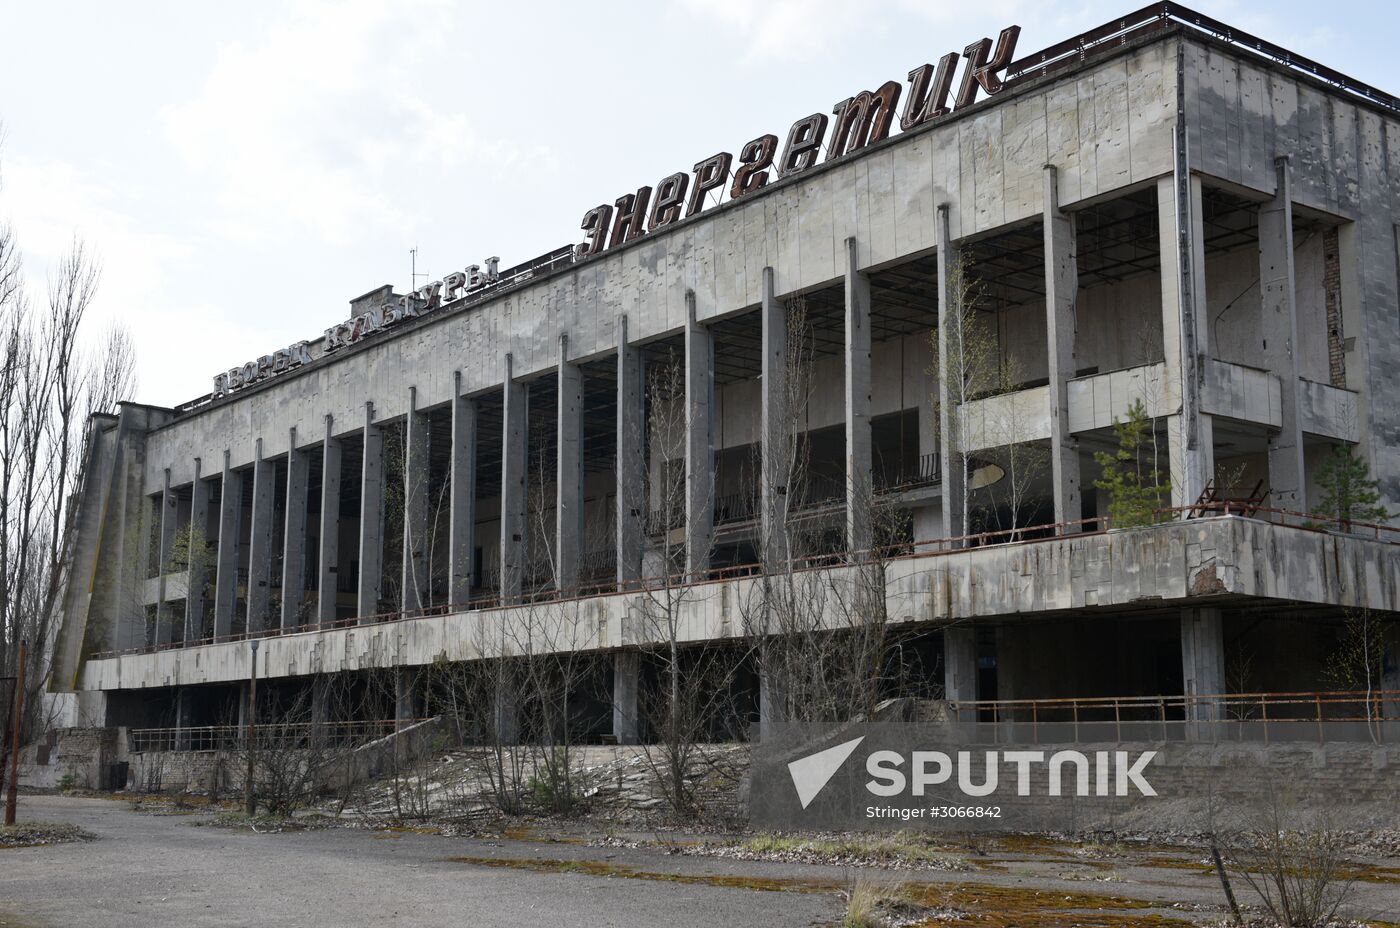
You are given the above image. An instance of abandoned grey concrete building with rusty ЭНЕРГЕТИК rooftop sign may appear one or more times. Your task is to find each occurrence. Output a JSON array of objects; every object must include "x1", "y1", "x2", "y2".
[{"x1": 38, "y1": 4, "x2": 1400, "y2": 742}]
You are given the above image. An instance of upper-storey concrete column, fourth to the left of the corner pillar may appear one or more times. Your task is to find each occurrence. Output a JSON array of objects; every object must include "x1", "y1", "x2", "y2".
[{"x1": 759, "y1": 267, "x2": 797, "y2": 571}]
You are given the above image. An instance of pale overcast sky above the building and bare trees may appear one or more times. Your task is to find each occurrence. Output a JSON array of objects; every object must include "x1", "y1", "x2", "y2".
[{"x1": 0, "y1": 0, "x2": 1400, "y2": 405}]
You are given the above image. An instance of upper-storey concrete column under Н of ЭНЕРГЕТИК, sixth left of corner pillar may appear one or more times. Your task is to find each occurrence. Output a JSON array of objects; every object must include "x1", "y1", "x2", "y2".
[{"x1": 617, "y1": 316, "x2": 647, "y2": 588}]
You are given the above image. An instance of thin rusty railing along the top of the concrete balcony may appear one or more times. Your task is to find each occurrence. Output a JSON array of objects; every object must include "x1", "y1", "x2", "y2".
[{"x1": 90, "y1": 509, "x2": 1400, "y2": 659}]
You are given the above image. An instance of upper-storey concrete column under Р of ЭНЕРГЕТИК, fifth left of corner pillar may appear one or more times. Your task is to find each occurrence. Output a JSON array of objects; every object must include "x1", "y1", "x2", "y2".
[{"x1": 686, "y1": 290, "x2": 714, "y2": 575}]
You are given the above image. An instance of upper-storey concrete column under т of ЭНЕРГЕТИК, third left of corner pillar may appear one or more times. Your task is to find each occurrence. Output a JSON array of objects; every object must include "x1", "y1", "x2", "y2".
[{"x1": 846, "y1": 237, "x2": 875, "y2": 554}]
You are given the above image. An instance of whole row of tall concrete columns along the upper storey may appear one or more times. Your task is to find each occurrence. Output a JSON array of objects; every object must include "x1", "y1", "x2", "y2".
[{"x1": 160, "y1": 161, "x2": 1303, "y2": 637}]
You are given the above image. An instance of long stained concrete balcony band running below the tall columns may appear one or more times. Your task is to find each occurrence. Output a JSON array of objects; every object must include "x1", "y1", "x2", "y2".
[{"x1": 81, "y1": 516, "x2": 1400, "y2": 690}]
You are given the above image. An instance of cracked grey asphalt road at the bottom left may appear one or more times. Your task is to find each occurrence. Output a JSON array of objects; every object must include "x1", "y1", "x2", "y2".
[{"x1": 0, "y1": 796, "x2": 839, "y2": 928}]
